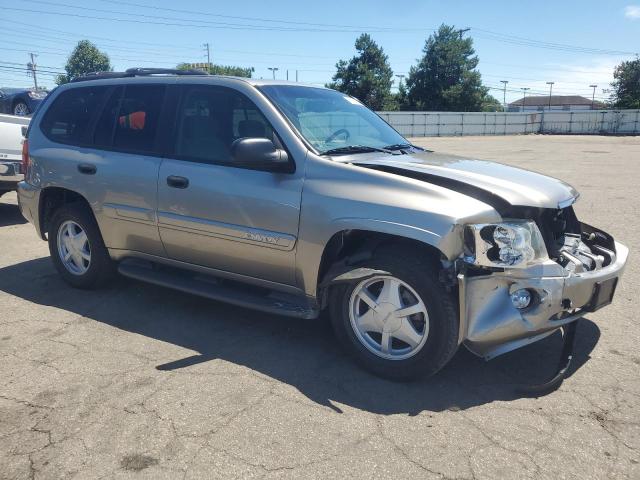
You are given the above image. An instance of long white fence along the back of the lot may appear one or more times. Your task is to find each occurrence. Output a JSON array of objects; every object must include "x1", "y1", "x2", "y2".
[{"x1": 378, "y1": 110, "x2": 640, "y2": 137}]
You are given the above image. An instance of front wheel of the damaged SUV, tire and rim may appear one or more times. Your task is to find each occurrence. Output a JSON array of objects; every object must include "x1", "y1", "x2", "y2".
[{"x1": 329, "y1": 249, "x2": 459, "y2": 380}]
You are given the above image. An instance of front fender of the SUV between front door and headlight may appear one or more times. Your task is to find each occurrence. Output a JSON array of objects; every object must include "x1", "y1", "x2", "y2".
[{"x1": 296, "y1": 154, "x2": 500, "y2": 296}]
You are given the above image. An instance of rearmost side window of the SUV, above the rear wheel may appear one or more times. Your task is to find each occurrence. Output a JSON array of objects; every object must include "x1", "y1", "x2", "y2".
[{"x1": 40, "y1": 86, "x2": 108, "y2": 145}]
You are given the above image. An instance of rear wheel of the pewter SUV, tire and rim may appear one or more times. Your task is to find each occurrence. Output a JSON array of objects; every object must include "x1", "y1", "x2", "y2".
[{"x1": 48, "y1": 203, "x2": 115, "y2": 289}]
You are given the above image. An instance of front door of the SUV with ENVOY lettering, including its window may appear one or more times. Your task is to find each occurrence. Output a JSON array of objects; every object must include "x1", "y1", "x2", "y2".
[{"x1": 158, "y1": 85, "x2": 302, "y2": 285}]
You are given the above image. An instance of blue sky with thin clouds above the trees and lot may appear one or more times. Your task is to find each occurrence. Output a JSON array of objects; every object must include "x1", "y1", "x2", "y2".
[{"x1": 0, "y1": 0, "x2": 640, "y2": 102}]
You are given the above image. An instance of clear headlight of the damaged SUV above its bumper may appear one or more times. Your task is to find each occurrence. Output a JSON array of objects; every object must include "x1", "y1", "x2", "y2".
[{"x1": 464, "y1": 220, "x2": 548, "y2": 268}]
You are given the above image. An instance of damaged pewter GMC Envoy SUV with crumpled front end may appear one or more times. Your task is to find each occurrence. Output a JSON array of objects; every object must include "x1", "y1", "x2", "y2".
[{"x1": 19, "y1": 69, "x2": 628, "y2": 379}]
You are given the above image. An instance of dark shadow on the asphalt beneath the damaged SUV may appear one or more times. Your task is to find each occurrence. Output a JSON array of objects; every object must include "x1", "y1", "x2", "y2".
[{"x1": 0, "y1": 258, "x2": 600, "y2": 415}]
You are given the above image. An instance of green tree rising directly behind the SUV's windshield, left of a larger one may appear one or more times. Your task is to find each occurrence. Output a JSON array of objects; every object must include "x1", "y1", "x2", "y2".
[{"x1": 327, "y1": 33, "x2": 394, "y2": 110}]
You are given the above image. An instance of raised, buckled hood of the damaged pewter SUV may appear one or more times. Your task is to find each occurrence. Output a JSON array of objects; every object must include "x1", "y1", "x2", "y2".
[{"x1": 350, "y1": 152, "x2": 579, "y2": 210}]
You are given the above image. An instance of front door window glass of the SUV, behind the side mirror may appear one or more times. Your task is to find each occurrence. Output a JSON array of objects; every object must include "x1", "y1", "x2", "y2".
[{"x1": 175, "y1": 85, "x2": 274, "y2": 165}]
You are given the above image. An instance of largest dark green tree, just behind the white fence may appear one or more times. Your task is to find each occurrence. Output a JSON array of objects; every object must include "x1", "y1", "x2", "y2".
[{"x1": 407, "y1": 24, "x2": 489, "y2": 112}]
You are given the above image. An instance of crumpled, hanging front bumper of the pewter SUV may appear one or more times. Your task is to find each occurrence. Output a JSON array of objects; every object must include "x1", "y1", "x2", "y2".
[{"x1": 458, "y1": 234, "x2": 629, "y2": 360}]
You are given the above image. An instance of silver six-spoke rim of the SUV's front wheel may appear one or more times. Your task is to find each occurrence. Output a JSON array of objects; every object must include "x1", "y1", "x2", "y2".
[{"x1": 349, "y1": 276, "x2": 429, "y2": 360}]
